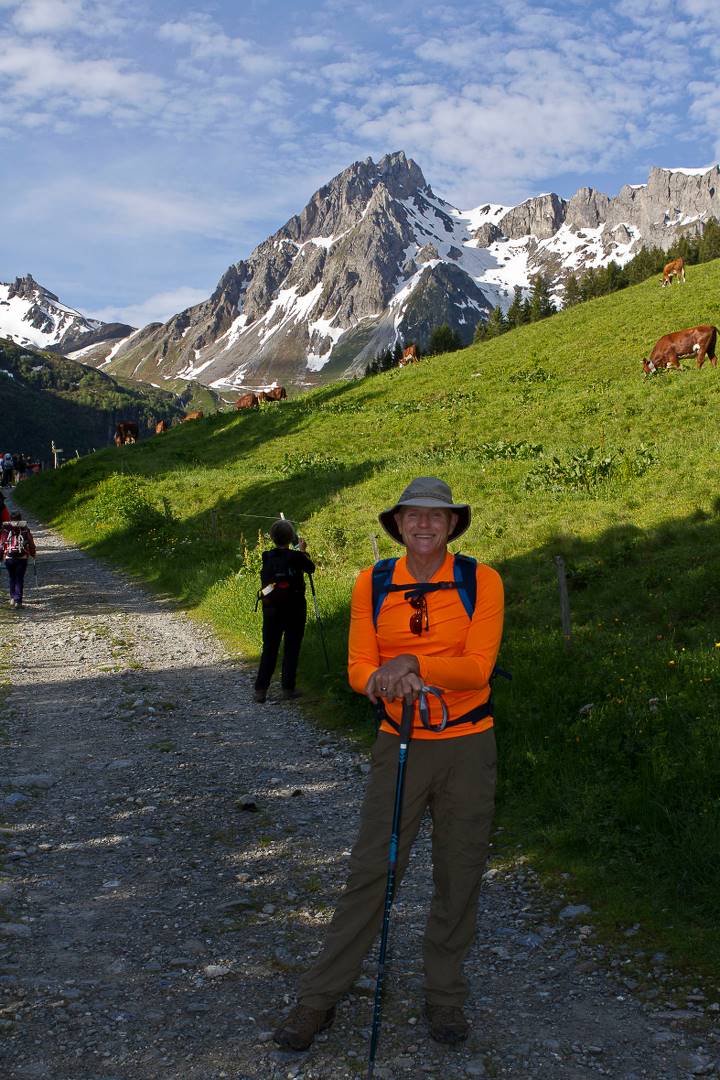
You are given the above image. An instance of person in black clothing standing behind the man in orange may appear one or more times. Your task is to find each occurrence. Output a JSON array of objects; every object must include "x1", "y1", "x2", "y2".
[{"x1": 255, "y1": 519, "x2": 315, "y2": 702}]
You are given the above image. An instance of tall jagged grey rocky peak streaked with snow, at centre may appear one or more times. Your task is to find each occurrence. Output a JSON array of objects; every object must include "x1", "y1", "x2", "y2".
[{"x1": 104, "y1": 152, "x2": 499, "y2": 389}]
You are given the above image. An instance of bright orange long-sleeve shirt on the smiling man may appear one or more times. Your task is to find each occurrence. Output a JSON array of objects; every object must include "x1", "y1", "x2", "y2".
[{"x1": 348, "y1": 552, "x2": 504, "y2": 739}]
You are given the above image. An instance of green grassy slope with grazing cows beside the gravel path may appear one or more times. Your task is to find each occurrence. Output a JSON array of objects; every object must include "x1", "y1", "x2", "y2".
[{"x1": 19, "y1": 262, "x2": 720, "y2": 971}]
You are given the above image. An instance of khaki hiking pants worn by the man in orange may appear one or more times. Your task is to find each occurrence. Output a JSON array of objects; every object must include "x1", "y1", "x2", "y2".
[{"x1": 298, "y1": 728, "x2": 495, "y2": 1010}]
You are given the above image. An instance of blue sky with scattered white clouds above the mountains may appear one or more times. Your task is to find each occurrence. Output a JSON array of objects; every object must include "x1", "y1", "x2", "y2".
[{"x1": 0, "y1": 0, "x2": 720, "y2": 325}]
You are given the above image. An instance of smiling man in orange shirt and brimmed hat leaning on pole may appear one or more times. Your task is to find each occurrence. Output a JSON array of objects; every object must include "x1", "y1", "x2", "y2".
[{"x1": 274, "y1": 476, "x2": 503, "y2": 1050}]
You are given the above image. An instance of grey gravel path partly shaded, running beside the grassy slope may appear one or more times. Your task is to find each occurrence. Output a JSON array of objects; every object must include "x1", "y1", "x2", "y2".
[{"x1": 0, "y1": 507, "x2": 719, "y2": 1080}]
